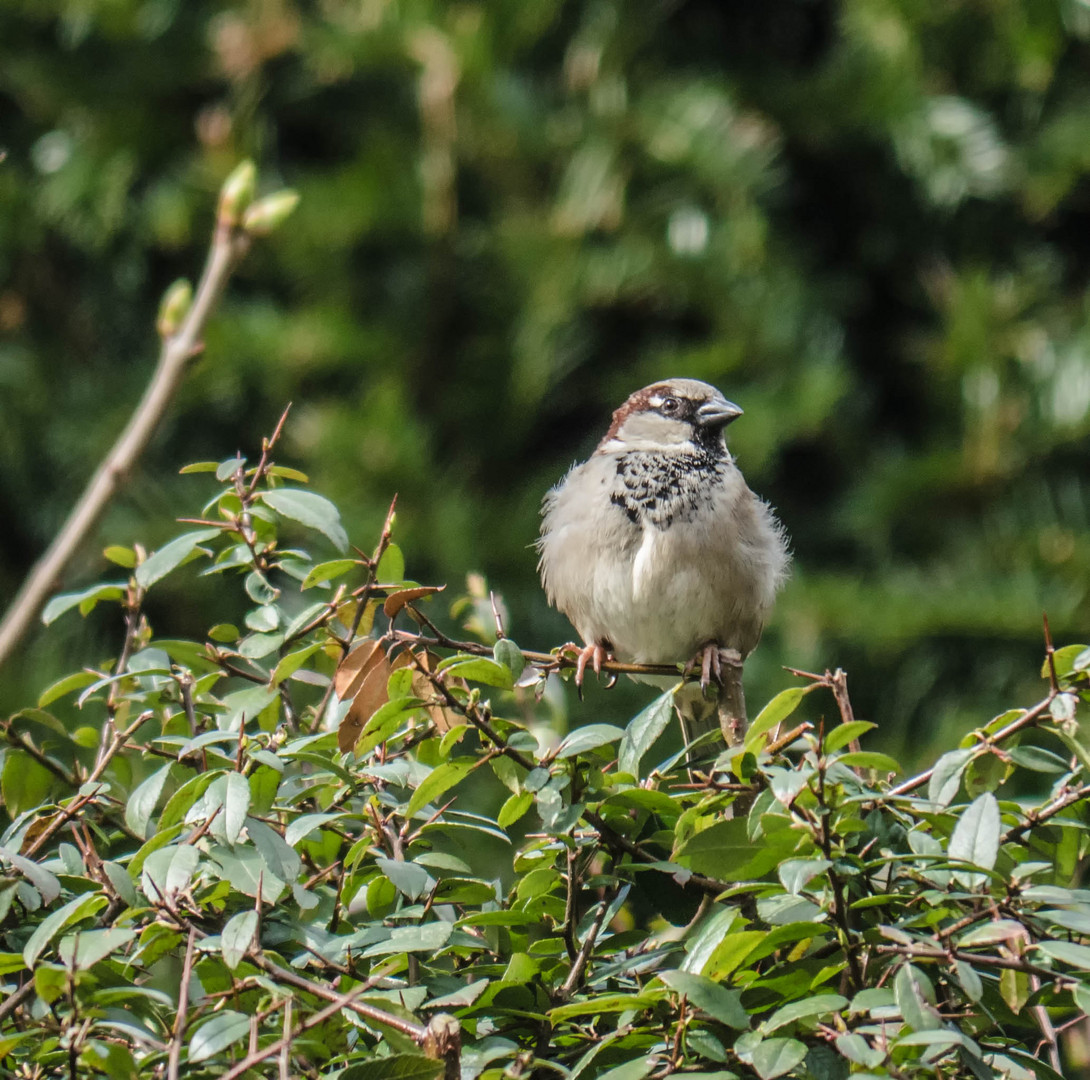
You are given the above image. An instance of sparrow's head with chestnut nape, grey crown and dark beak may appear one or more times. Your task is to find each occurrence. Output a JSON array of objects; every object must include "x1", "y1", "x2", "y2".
[{"x1": 597, "y1": 379, "x2": 742, "y2": 453}]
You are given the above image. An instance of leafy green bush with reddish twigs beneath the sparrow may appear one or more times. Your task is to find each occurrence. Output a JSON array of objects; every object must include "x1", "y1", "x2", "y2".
[{"x1": 0, "y1": 440, "x2": 1090, "y2": 1080}]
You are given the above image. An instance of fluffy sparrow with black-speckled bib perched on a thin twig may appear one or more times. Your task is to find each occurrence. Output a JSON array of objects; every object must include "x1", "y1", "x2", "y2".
[{"x1": 537, "y1": 379, "x2": 789, "y2": 758}]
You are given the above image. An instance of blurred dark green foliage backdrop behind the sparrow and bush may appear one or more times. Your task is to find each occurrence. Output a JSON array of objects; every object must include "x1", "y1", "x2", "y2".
[{"x1": 0, "y1": 0, "x2": 1090, "y2": 763}]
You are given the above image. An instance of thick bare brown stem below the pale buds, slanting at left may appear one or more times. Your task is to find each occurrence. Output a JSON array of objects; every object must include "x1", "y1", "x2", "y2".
[{"x1": 0, "y1": 174, "x2": 258, "y2": 666}]
